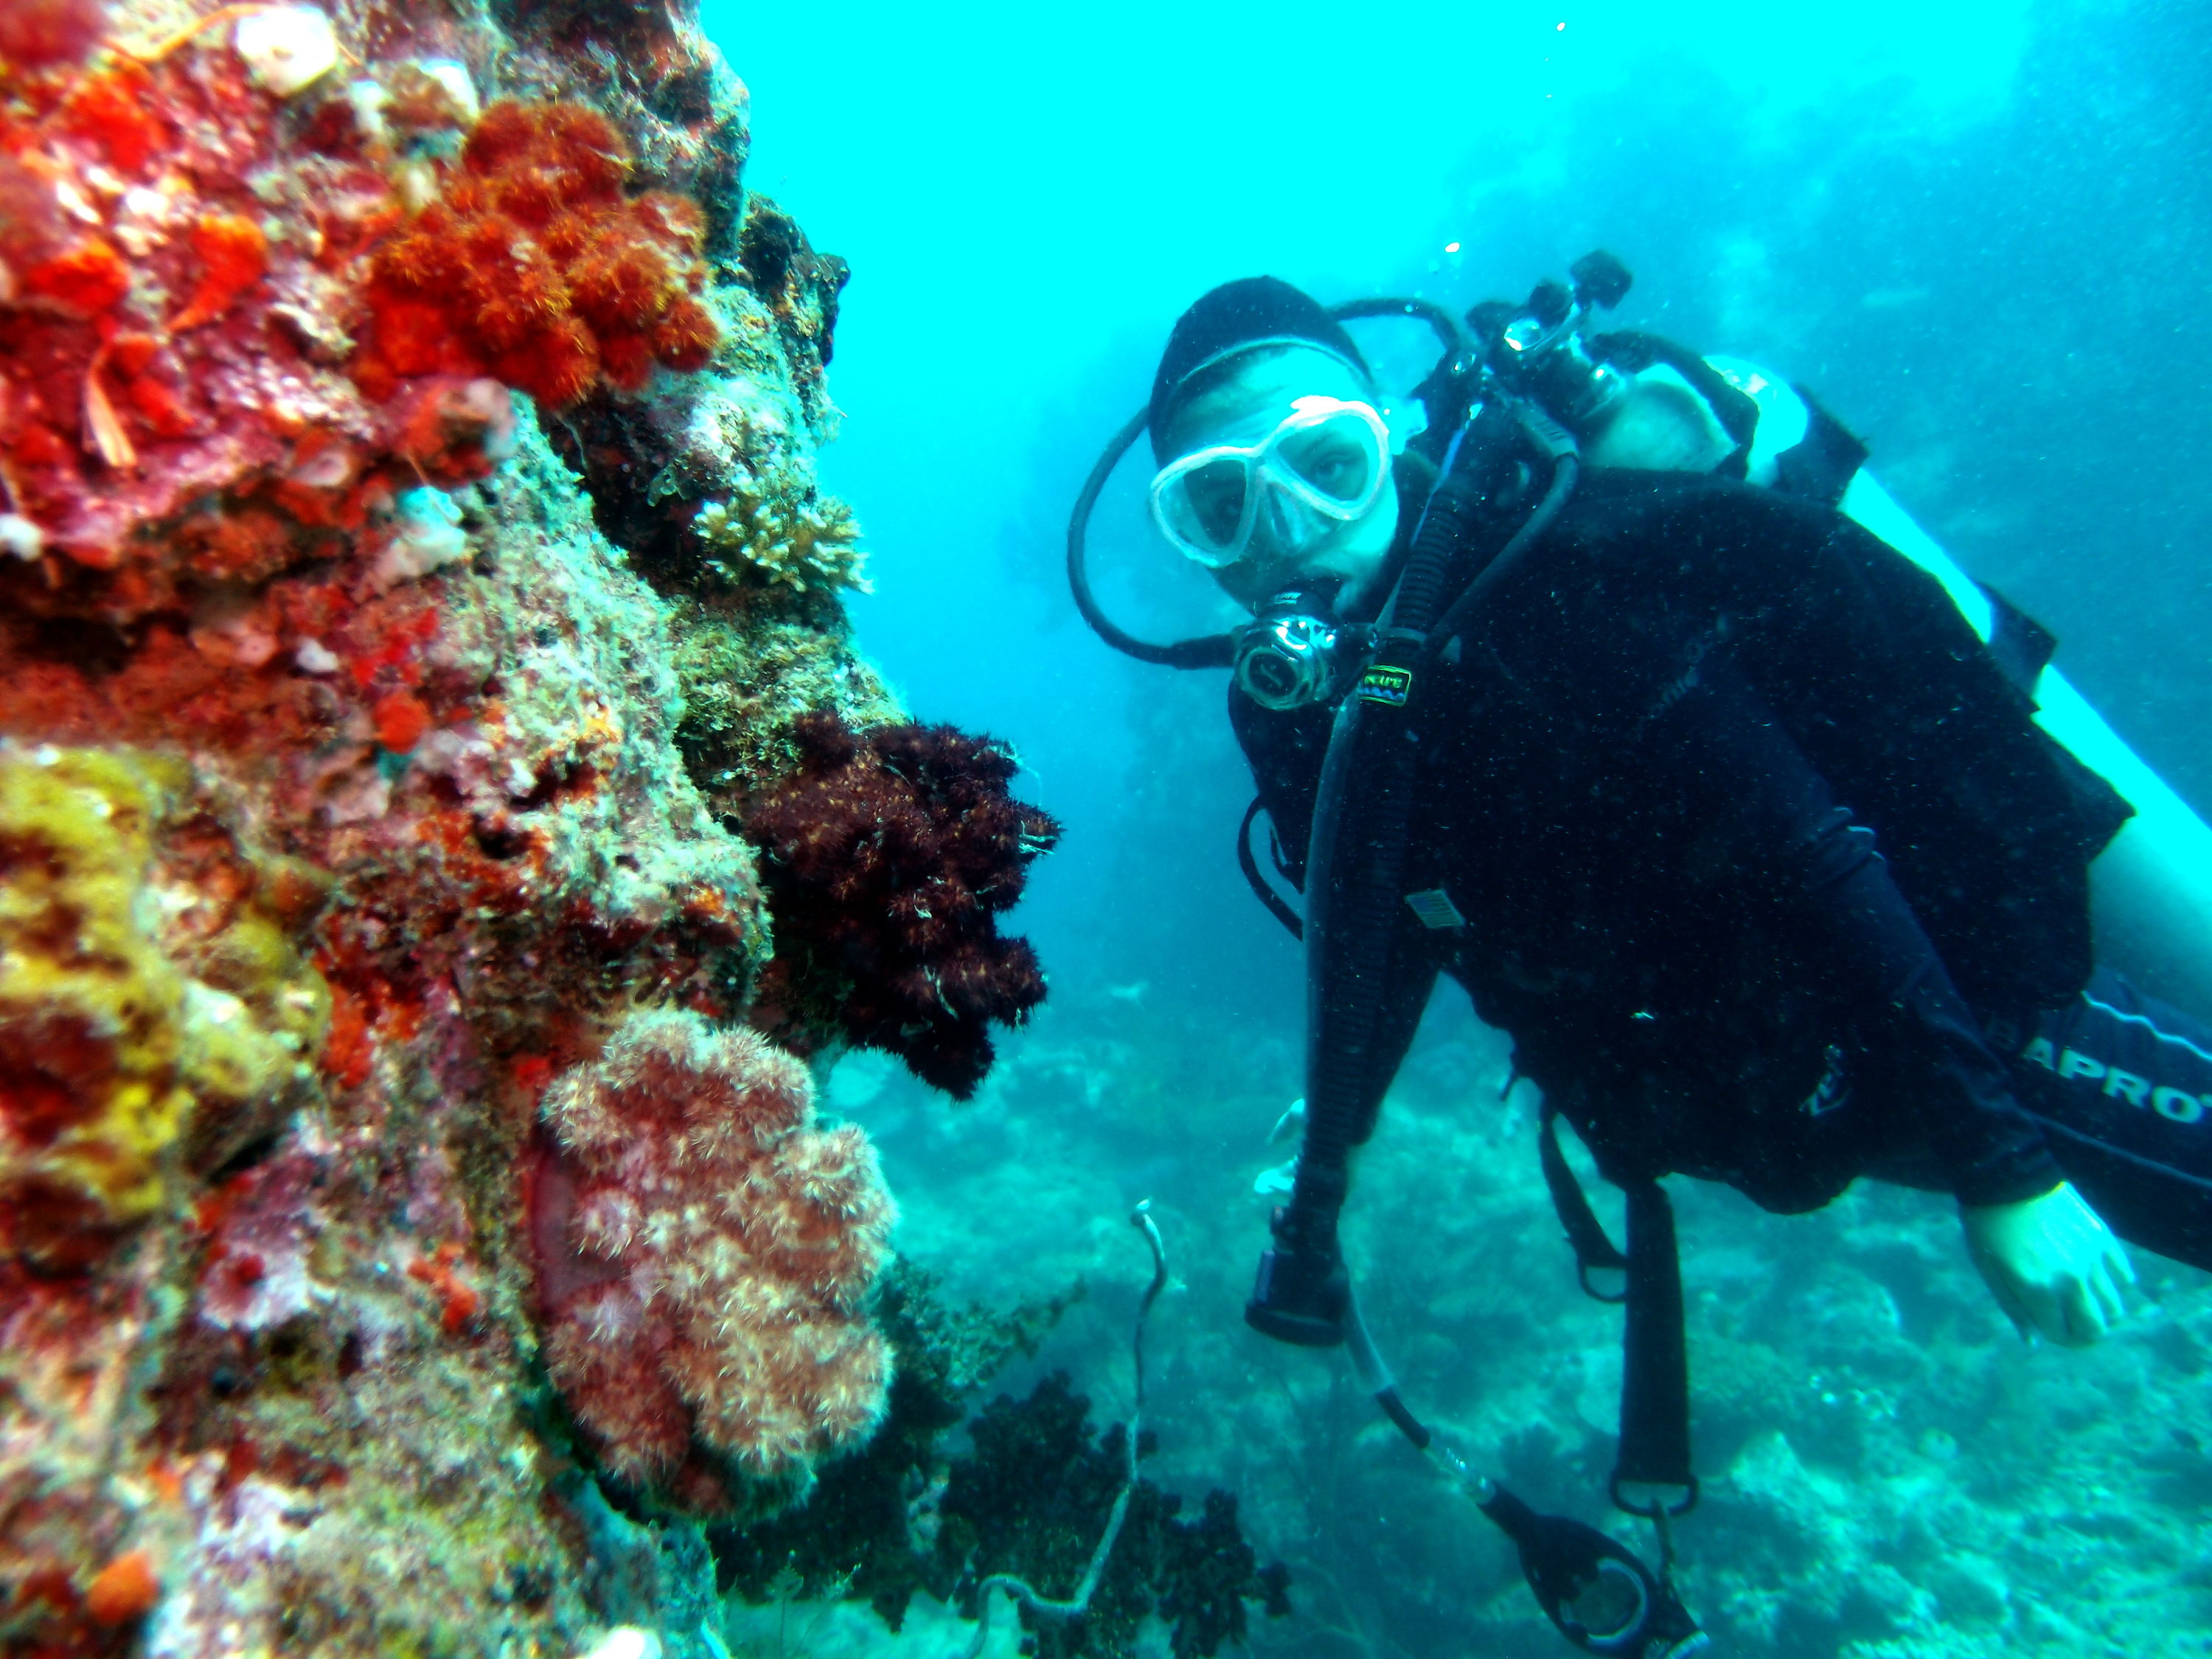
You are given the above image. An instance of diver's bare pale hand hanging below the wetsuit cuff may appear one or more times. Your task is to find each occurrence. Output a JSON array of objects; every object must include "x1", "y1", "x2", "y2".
[{"x1": 1960, "y1": 1181, "x2": 2135, "y2": 1347}]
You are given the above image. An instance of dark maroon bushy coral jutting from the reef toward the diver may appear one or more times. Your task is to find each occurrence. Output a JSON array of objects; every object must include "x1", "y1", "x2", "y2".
[{"x1": 745, "y1": 714, "x2": 1060, "y2": 1099}]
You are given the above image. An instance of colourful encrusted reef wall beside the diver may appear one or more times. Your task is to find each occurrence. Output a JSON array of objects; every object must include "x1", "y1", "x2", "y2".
[{"x1": 0, "y1": 0, "x2": 1042, "y2": 1657}]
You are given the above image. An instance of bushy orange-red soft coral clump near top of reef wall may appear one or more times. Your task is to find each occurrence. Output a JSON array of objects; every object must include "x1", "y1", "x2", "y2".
[{"x1": 354, "y1": 100, "x2": 721, "y2": 409}]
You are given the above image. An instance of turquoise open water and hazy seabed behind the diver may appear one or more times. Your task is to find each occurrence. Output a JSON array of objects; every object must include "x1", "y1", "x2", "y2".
[{"x1": 706, "y1": 0, "x2": 2212, "y2": 1659}]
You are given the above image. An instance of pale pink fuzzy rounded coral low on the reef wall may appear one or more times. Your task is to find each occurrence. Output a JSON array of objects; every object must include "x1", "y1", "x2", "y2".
[{"x1": 531, "y1": 1011, "x2": 891, "y2": 1509}]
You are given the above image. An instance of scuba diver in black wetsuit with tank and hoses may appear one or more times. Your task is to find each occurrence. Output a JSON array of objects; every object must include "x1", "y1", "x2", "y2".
[{"x1": 1068, "y1": 254, "x2": 2212, "y2": 1655}]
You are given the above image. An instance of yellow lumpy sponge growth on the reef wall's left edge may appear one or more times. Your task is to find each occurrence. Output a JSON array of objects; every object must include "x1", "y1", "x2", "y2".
[{"x1": 0, "y1": 743, "x2": 330, "y2": 1270}]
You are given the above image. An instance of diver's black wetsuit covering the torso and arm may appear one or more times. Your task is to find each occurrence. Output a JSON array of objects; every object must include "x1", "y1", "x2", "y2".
[{"x1": 1230, "y1": 471, "x2": 2212, "y2": 1254}]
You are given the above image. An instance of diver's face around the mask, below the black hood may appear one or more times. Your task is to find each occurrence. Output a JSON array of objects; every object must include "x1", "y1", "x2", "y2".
[{"x1": 1166, "y1": 345, "x2": 1398, "y2": 611}]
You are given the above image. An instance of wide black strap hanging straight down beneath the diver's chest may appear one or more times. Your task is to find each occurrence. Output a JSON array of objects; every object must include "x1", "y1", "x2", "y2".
[{"x1": 1610, "y1": 1179, "x2": 1697, "y2": 1517}]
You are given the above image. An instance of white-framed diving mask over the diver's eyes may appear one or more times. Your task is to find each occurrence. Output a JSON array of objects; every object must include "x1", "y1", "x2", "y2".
[{"x1": 1152, "y1": 396, "x2": 1389, "y2": 571}]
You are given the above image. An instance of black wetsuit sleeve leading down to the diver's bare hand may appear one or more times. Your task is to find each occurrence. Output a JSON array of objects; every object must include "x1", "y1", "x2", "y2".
[{"x1": 1650, "y1": 657, "x2": 2064, "y2": 1206}]
